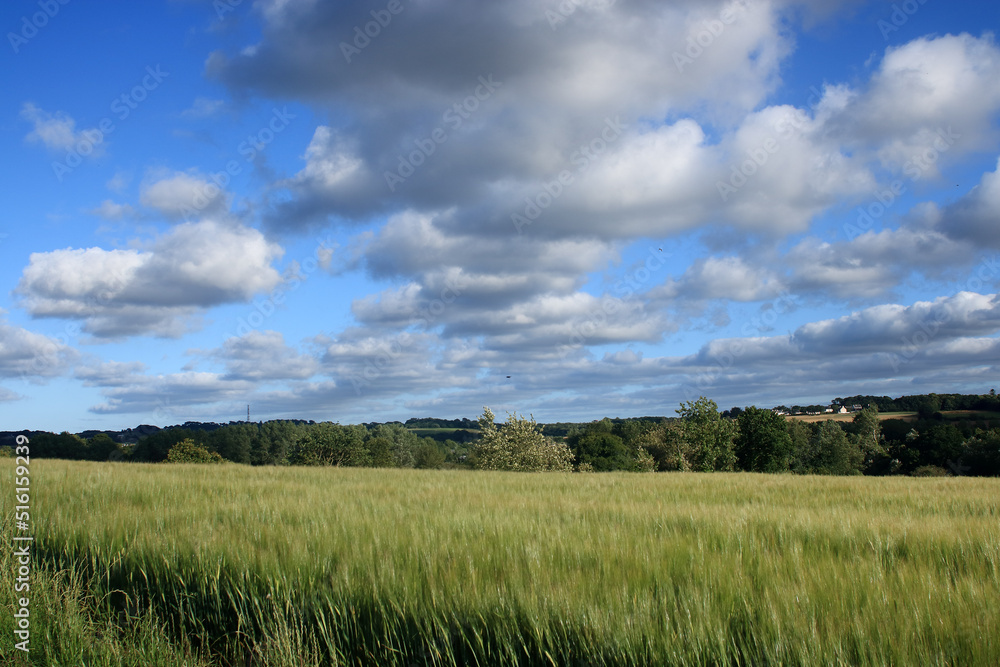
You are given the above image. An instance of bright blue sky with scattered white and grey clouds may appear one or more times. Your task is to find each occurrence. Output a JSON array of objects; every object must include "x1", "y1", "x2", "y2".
[{"x1": 0, "y1": 0, "x2": 1000, "y2": 431}]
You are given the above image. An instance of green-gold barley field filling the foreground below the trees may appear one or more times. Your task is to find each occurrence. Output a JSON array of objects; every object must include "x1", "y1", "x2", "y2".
[{"x1": 0, "y1": 460, "x2": 1000, "y2": 665}]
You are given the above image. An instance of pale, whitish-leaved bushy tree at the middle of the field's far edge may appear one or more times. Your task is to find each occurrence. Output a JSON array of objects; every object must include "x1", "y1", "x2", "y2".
[{"x1": 475, "y1": 407, "x2": 573, "y2": 472}]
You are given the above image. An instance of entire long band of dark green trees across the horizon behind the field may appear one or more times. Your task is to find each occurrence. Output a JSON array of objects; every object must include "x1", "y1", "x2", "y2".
[{"x1": 7, "y1": 393, "x2": 1000, "y2": 476}]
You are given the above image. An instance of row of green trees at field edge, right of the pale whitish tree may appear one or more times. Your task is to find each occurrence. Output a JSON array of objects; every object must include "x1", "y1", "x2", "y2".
[{"x1": 532, "y1": 397, "x2": 1000, "y2": 476}]
